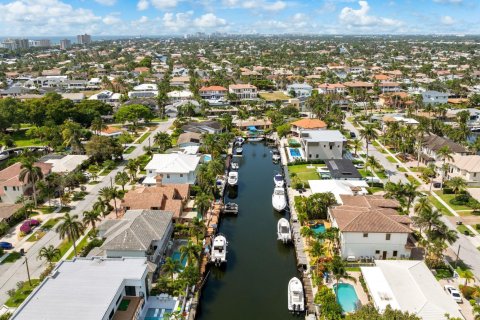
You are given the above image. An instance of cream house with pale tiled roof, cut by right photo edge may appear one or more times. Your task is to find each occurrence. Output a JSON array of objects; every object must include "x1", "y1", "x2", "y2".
[{"x1": 447, "y1": 155, "x2": 480, "y2": 186}]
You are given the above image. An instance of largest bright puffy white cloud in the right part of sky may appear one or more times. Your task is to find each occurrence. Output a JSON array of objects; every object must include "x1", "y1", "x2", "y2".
[{"x1": 339, "y1": 0, "x2": 402, "y2": 27}]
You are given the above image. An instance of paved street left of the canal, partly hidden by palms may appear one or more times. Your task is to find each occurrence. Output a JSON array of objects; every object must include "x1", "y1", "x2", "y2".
[{"x1": 0, "y1": 120, "x2": 173, "y2": 306}]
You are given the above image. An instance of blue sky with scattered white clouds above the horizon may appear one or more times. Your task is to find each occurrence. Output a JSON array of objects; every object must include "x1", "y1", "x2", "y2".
[{"x1": 0, "y1": 0, "x2": 480, "y2": 37}]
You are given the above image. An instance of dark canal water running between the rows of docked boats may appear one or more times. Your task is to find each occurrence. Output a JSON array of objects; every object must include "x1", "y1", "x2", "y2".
[{"x1": 197, "y1": 142, "x2": 299, "y2": 320}]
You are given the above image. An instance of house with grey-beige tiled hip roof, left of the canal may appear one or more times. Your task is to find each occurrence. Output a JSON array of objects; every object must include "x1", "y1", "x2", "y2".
[{"x1": 92, "y1": 210, "x2": 173, "y2": 264}]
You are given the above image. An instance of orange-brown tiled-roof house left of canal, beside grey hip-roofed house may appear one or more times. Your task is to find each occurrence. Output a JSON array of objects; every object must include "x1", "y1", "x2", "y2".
[{"x1": 120, "y1": 175, "x2": 190, "y2": 219}]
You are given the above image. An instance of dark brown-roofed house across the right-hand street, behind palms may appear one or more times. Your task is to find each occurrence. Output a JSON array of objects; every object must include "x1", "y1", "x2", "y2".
[{"x1": 420, "y1": 134, "x2": 469, "y2": 164}]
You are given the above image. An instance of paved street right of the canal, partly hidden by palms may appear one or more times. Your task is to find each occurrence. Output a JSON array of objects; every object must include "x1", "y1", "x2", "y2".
[{"x1": 345, "y1": 120, "x2": 480, "y2": 280}]
